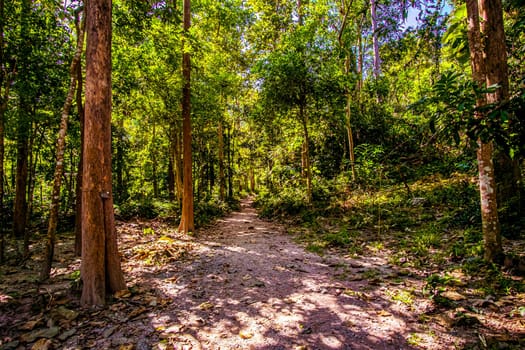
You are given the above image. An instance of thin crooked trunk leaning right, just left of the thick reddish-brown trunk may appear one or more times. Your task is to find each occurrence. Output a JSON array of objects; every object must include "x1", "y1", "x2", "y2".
[{"x1": 40, "y1": 13, "x2": 84, "y2": 280}]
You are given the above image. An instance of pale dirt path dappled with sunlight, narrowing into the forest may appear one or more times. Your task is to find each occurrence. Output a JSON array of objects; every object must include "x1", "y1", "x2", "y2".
[{"x1": 136, "y1": 201, "x2": 426, "y2": 349}]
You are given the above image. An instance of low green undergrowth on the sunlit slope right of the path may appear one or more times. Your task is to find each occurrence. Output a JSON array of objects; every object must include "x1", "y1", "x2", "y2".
[{"x1": 256, "y1": 173, "x2": 523, "y2": 295}]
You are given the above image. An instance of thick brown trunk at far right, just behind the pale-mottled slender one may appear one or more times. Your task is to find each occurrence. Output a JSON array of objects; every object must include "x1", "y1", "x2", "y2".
[{"x1": 479, "y1": 0, "x2": 523, "y2": 228}]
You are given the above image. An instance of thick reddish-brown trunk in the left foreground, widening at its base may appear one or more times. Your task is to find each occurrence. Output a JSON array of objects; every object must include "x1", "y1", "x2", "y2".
[{"x1": 80, "y1": 0, "x2": 126, "y2": 306}]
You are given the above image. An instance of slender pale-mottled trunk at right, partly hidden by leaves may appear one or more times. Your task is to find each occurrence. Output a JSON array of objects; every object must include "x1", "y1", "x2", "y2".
[{"x1": 467, "y1": 0, "x2": 502, "y2": 261}]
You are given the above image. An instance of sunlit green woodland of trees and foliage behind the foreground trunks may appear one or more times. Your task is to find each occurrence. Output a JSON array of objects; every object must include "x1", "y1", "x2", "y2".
[{"x1": 0, "y1": 0, "x2": 525, "y2": 300}]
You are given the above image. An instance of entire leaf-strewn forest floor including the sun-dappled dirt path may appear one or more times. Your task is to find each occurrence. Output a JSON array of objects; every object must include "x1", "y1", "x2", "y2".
[{"x1": 0, "y1": 199, "x2": 525, "y2": 350}]
